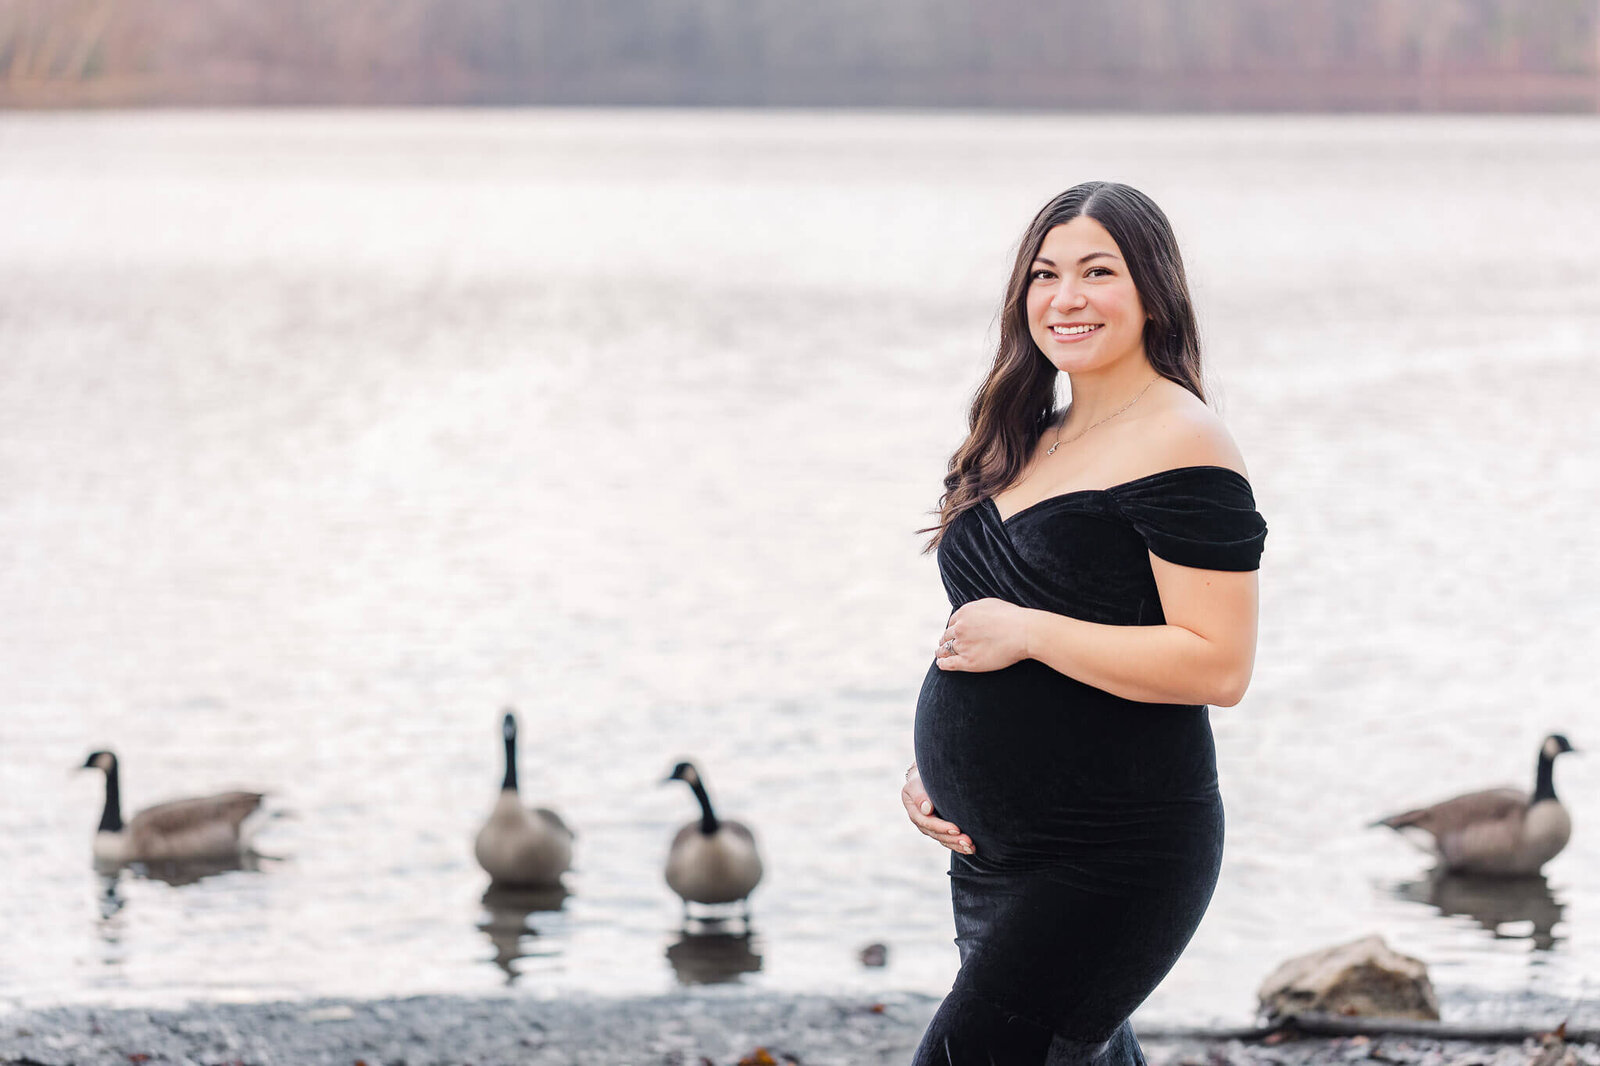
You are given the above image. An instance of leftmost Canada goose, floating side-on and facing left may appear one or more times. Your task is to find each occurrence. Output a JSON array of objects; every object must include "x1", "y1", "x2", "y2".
[{"x1": 80, "y1": 751, "x2": 262, "y2": 866}]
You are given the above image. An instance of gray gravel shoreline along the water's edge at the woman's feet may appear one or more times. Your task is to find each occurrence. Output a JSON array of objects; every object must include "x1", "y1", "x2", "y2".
[{"x1": 0, "y1": 991, "x2": 1600, "y2": 1066}]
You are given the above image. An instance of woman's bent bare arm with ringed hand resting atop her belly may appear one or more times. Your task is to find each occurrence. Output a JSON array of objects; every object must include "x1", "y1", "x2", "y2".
[{"x1": 938, "y1": 555, "x2": 1256, "y2": 707}]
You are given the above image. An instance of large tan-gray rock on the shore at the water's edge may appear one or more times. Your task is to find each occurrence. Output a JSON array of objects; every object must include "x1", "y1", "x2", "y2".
[{"x1": 1258, "y1": 935, "x2": 1438, "y2": 1021}]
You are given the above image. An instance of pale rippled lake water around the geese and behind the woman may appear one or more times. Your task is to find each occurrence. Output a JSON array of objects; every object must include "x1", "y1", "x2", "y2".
[{"x1": 0, "y1": 110, "x2": 1600, "y2": 1023}]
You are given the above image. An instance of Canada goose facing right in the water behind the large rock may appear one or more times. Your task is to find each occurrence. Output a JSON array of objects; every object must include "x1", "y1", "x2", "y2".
[{"x1": 1373, "y1": 733, "x2": 1578, "y2": 877}]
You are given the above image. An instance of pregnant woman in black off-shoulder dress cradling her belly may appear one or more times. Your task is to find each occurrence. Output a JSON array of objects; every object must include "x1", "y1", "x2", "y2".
[{"x1": 901, "y1": 182, "x2": 1266, "y2": 1066}]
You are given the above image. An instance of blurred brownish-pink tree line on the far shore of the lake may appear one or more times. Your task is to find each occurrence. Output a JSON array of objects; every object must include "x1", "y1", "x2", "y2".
[{"x1": 0, "y1": 0, "x2": 1600, "y2": 112}]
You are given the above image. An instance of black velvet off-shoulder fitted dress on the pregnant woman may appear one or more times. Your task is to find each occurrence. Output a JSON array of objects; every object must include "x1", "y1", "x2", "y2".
[{"x1": 914, "y1": 466, "x2": 1267, "y2": 1066}]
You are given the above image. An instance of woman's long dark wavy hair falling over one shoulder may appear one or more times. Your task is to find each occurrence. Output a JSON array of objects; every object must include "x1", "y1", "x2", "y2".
[{"x1": 922, "y1": 181, "x2": 1205, "y2": 551}]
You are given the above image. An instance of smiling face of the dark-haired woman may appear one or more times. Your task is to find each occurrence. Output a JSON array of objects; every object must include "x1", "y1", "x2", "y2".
[{"x1": 1027, "y1": 214, "x2": 1147, "y2": 373}]
